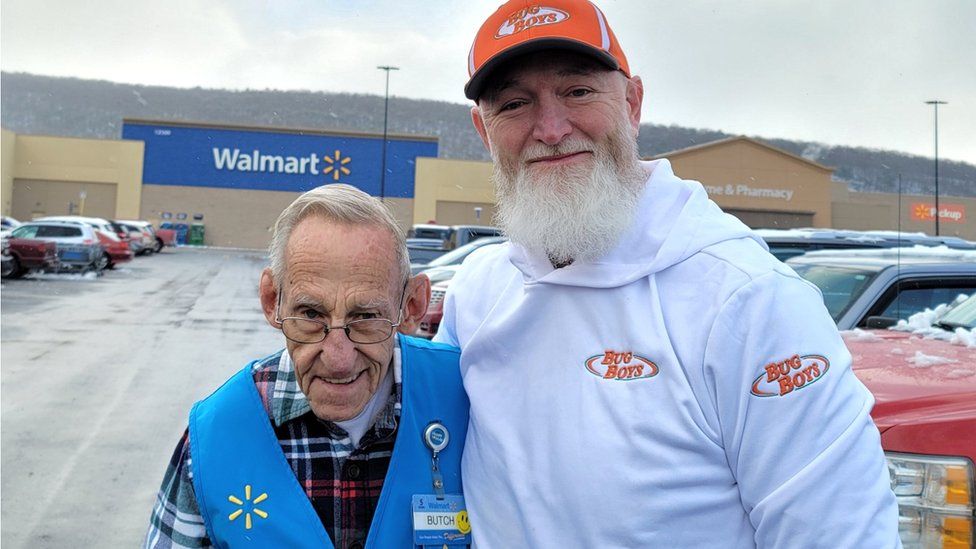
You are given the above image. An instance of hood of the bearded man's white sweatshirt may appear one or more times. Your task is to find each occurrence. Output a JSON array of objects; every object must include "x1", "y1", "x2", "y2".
[{"x1": 509, "y1": 159, "x2": 768, "y2": 288}]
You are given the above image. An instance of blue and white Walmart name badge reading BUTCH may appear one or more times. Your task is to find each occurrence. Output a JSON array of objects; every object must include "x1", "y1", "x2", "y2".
[{"x1": 410, "y1": 494, "x2": 471, "y2": 547}]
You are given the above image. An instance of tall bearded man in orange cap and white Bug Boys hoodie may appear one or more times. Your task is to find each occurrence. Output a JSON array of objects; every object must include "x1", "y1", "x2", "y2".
[{"x1": 435, "y1": 0, "x2": 899, "y2": 548}]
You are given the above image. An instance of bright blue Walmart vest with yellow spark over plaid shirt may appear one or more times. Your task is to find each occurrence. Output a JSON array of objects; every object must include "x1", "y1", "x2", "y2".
[{"x1": 189, "y1": 335, "x2": 468, "y2": 548}]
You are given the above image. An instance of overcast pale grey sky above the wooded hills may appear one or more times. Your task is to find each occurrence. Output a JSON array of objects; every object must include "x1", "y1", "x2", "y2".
[{"x1": 0, "y1": 0, "x2": 976, "y2": 164}]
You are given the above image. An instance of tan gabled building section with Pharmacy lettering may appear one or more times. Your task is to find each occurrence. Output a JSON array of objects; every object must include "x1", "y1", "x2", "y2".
[{"x1": 658, "y1": 137, "x2": 833, "y2": 227}]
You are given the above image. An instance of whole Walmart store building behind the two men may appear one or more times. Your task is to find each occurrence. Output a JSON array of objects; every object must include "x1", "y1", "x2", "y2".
[{"x1": 0, "y1": 120, "x2": 976, "y2": 248}]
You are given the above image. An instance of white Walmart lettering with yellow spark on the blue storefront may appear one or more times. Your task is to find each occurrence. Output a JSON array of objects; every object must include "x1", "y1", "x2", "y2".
[{"x1": 213, "y1": 147, "x2": 352, "y2": 181}]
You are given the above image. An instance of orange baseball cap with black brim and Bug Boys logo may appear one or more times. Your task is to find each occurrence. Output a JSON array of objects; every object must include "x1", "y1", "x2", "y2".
[{"x1": 464, "y1": 0, "x2": 630, "y2": 100}]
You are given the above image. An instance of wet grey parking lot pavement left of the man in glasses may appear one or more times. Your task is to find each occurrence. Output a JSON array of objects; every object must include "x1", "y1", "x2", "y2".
[{"x1": 0, "y1": 248, "x2": 284, "y2": 548}]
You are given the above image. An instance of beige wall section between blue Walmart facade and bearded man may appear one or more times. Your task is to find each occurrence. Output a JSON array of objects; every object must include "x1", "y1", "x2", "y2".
[{"x1": 413, "y1": 158, "x2": 495, "y2": 225}]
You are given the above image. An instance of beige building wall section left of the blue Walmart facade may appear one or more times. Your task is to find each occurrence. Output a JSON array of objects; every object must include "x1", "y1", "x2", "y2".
[{"x1": 4, "y1": 135, "x2": 144, "y2": 219}]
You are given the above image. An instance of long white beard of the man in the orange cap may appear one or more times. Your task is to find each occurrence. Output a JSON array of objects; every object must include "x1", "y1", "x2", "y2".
[{"x1": 492, "y1": 124, "x2": 647, "y2": 266}]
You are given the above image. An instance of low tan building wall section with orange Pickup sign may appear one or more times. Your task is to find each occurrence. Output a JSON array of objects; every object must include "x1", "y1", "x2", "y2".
[{"x1": 831, "y1": 182, "x2": 976, "y2": 241}]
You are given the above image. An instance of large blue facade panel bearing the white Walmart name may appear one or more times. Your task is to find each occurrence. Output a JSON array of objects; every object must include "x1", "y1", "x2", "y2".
[{"x1": 122, "y1": 120, "x2": 437, "y2": 198}]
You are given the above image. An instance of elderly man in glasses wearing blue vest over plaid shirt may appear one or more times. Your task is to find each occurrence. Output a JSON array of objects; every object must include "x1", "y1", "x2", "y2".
[{"x1": 146, "y1": 185, "x2": 470, "y2": 548}]
